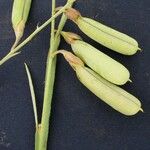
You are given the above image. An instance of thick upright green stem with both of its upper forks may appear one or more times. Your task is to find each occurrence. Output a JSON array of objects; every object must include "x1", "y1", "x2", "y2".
[{"x1": 35, "y1": 0, "x2": 74, "y2": 150}]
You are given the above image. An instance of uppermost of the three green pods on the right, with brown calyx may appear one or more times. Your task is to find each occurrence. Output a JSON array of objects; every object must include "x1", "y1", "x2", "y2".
[{"x1": 66, "y1": 9, "x2": 140, "y2": 55}]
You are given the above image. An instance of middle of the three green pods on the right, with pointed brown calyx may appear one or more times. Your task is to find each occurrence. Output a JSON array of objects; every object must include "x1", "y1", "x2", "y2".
[{"x1": 62, "y1": 32, "x2": 130, "y2": 85}]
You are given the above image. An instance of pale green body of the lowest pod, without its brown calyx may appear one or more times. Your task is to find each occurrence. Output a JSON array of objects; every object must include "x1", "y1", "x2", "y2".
[{"x1": 76, "y1": 67, "x2": 142, "y2": 116}]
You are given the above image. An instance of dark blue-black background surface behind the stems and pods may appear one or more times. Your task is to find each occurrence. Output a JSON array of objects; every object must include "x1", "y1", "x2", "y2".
[{"x1": 0, "y1": 0, "x2": 150, "y2": 150}]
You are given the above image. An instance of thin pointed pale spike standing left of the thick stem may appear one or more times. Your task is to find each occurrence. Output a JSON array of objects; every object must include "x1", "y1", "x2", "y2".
[{"x1": 24, "y1": 63, "x2": 38, "y2": 129}]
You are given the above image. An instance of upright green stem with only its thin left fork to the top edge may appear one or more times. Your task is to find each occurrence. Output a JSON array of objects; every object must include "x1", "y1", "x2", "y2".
[{"x1": 35, "y1": 0, "x2": 56, "y2": 150}]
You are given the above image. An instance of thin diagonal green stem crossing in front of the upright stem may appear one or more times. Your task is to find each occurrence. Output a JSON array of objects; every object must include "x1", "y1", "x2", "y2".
[{"x1": 0, "y1": 0, "x2": 74, "y2": 65}]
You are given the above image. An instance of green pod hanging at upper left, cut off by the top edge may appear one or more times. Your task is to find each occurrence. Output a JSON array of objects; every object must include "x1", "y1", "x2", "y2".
[{"x1": 12, "y1": 0, "x2": 31, "y2": 49}]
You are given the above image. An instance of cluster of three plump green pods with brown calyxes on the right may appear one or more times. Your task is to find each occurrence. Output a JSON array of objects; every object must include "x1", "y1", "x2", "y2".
[{"x1": 59, "y1": 13, "x2": 143, "y2": 116}]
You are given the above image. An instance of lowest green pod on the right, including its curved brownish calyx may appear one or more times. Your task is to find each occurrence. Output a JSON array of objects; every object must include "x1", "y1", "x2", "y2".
[{"x1": 53, "y1": 50, "x2": 143, "y2": 116}]
